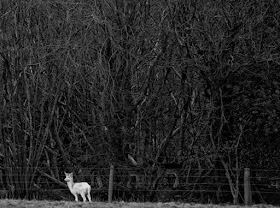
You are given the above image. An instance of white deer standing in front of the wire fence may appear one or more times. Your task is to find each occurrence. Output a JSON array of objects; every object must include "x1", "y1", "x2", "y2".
[{"x1": 64, "y1": 173, "x2": 91, "y2": 202}]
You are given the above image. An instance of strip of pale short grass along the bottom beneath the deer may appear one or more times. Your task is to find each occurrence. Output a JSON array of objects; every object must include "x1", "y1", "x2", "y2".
[{"x1": 0, "y1": 199, "x2": 275, "y2": 208}]
